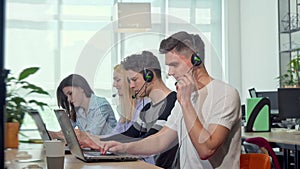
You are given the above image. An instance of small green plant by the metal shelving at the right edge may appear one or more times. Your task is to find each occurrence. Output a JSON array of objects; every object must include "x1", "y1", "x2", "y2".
[{"x1": 277, "y1": 55, "x2": 300, "y2": 87}]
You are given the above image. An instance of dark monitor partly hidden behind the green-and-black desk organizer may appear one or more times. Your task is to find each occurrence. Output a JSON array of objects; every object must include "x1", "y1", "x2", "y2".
[{"x1": 256, "y1": 91, "x2": 278, "y2": 114}]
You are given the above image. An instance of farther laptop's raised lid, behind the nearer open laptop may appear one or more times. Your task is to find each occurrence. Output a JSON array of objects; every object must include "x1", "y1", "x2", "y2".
[{"x1": 28, "y1": 110, "x2": 71, "y2": 154}]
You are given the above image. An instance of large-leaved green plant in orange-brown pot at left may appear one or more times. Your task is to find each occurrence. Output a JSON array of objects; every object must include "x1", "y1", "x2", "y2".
[{"x1": 5, "y1": 67, "x2": 50, "y2": 148}]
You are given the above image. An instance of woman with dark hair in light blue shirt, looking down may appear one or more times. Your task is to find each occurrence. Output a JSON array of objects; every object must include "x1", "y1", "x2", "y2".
[{"x1": 56, "y1": 74, "x2": 116, "y2": 135}]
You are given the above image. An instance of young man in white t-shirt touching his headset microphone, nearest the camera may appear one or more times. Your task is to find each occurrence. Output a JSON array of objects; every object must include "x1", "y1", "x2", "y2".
[{"x1": 96, "y1": 32, "x2": 241, "y2": 169}]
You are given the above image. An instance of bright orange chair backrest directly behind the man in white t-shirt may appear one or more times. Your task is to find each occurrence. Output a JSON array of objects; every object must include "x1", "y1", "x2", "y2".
[{"x1": 240, "y1": 153, "x2": 271, "y2": 169}]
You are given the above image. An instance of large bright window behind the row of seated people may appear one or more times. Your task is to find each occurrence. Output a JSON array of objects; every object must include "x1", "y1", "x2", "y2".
[{"x1": 5, "y1": 0, "x2": 222, "y2": 130}]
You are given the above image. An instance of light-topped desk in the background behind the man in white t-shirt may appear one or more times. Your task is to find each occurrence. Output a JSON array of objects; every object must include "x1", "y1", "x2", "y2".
[{"x1": 242, "y1": 128, "x2": 300, "y2": 169}]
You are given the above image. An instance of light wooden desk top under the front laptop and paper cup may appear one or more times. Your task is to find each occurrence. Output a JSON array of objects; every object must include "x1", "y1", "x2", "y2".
[{"x1": 5, "y1": 144, "x2": 159, "y2": 169}]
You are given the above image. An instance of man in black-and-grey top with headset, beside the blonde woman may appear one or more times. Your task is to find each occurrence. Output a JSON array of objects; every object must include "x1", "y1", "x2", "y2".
[{"x1": 77, "y1": 51, "x2": 177, "y2": 168}]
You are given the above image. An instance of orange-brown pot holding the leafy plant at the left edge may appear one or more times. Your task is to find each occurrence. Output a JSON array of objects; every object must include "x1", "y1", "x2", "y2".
[{"x1": 5, "y1": 122, "x2": 20, "y2": 148}]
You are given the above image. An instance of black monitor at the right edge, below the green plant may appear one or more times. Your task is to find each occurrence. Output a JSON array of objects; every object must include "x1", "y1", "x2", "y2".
[{"x1": 278, "y1": 88, "x2": 300, "y2": 120}]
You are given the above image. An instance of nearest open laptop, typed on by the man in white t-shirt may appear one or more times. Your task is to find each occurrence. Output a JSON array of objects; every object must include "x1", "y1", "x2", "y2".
[{"x1": 54, "y1": 109, "x2": 139, "y2": 162}]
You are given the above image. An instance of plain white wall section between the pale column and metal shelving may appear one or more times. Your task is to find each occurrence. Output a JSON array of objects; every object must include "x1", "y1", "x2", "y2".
[{"x1": 241, "y1": 0, "x2": 279, "y2": 103}]
